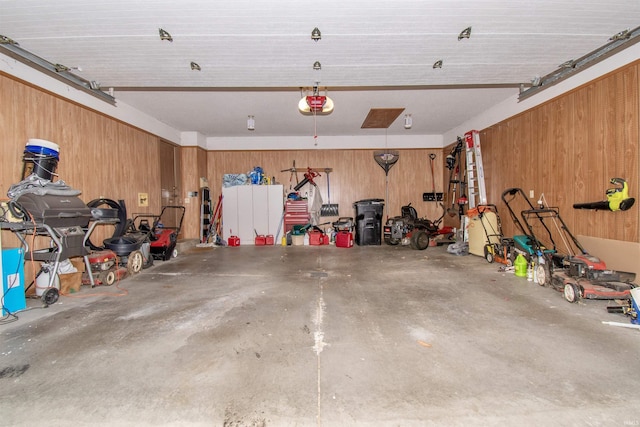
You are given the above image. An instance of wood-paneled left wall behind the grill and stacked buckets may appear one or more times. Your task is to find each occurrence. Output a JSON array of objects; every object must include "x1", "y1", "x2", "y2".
[{"x1": 0, "y1": 74, "x2": 160, "y2": 246}]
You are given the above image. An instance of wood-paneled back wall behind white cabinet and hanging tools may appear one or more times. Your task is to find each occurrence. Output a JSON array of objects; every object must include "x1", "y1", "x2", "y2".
[{"x1": 207, "y1": 149, "x2": 444, "y2": 226}]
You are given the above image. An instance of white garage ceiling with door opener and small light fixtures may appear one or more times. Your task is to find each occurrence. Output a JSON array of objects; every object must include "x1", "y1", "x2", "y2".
[{"x1": 0, "y1": 0, "x2": 640, "y2": 137}]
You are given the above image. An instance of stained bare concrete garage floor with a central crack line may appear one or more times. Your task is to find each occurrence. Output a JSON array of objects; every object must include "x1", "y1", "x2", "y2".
[{"x1": 0, "y1": 245, "x2": 640, "y2": 426}]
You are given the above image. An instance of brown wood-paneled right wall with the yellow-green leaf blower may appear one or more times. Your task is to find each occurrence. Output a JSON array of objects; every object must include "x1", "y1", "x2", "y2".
[{"x1": 480, "y1": 63, "x2": 640, "y2": 242}]
